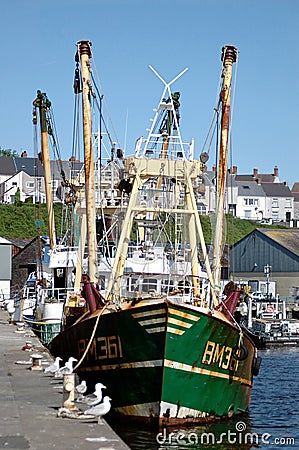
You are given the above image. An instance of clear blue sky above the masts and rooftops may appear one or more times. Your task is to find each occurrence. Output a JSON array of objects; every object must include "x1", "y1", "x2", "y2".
[{"x1": 0, "y1": 0, "x2": 299, "y2": 186}]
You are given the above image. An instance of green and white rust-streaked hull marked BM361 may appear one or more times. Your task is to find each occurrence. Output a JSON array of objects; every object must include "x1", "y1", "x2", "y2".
[{"x1": 49, "y1": 301, "x2": 255, "y2": 423}]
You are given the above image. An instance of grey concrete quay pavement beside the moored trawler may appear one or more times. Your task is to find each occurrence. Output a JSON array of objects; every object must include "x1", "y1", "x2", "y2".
[{"x1": 0, "y1": 308, "x2": 129, "y2": 450}]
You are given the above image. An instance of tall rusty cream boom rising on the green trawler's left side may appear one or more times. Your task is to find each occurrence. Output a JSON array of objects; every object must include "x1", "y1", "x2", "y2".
[{"x1": 76, "y1": 41, "x2": 97, "y2": 283}]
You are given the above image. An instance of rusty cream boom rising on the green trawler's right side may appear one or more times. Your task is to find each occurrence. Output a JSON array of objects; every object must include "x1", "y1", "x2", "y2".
[{"x1": 213, "y1": 45, "x2": 238, "y2": 292}]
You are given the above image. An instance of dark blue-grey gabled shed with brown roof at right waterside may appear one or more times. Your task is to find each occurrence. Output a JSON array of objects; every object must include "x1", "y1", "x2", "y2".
[{"x1": 230, "y1": 228, "x2": 299, "y2": 297}]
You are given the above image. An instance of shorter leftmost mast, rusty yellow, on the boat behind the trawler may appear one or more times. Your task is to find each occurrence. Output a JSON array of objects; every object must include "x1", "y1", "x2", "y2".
[{"x1": 33, "y1": 91, "x2": 56, "y2": 249}]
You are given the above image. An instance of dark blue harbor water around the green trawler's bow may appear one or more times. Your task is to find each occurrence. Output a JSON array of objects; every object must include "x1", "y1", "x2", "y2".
[{"x1": 116, "y1": 348, "x2": 299, "y2": 450}]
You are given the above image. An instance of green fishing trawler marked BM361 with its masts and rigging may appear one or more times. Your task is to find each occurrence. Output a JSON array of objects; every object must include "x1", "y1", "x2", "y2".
[{"x1": 49, "y1": 41, "x2": 258, "y2": 426}]
